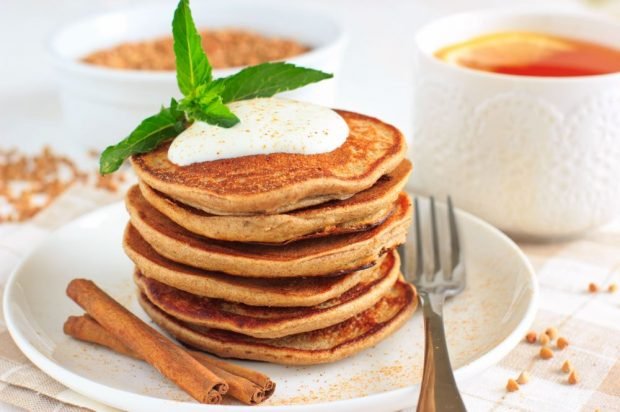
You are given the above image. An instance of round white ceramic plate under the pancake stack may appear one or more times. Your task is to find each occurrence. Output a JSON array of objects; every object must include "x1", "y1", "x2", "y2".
[{"x1": 4, "y1": 198, "x2": 538, "y2": 412}]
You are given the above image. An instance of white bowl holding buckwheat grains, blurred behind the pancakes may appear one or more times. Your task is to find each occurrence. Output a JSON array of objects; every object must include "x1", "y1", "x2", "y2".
[{"x1": 51, "y1": 0, "x2": 345, "y2": 148}]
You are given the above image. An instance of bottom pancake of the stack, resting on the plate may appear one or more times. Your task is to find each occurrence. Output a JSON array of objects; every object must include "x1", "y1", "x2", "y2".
[{"x1": 139, "y1": 279, "x2": 417, "y2": 365}]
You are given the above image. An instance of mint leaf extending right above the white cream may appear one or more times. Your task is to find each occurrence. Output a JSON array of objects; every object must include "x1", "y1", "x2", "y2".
[{"x1": 213, "y1": 62, "x2": 334, "y2": 103}]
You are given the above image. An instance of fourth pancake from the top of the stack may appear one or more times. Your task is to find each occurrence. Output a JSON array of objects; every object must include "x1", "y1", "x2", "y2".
[{"x1": 123, "y1": 225, "x2": 384, "y2": 306}]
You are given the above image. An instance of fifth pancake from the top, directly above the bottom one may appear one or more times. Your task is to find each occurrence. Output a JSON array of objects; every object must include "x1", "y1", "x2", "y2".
[{"x1": 134, "y1": 251, "x2": 400, "y2": 338}]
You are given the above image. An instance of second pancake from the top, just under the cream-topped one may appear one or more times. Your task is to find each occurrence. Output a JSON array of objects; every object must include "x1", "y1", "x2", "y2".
[{"x1": 140, "y1": 160, "x2": 411, "y2": 243}]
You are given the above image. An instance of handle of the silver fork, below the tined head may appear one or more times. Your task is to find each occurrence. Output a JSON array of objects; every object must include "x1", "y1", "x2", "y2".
[{"x1": 417, "y1": 294, "x2": 467, "y2": 412}]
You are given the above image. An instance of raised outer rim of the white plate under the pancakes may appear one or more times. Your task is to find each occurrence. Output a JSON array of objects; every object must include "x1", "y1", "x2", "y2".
[{"x1": 2, "y1": 198, "x2": 540, "y2": 412}]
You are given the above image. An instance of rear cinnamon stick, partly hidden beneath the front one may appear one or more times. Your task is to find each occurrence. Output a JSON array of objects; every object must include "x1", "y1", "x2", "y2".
[{"x1": 64, "y1": 315, "x2": 275, "y2": 405}]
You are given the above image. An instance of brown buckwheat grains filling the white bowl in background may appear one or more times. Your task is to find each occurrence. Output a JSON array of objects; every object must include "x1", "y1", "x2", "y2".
[{"x1": 82, "y1": 28, "x2": 310, "y2": 71}]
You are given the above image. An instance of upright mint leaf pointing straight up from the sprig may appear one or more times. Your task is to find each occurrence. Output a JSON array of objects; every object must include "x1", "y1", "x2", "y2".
[{"x1": 172, "y1": 0, "x2": 212, "y2": 96}]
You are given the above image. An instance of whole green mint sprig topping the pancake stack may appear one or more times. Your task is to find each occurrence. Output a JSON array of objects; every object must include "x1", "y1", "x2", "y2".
[{"x1": 99, "y1": 0, "x2": 333, "y2": 175}]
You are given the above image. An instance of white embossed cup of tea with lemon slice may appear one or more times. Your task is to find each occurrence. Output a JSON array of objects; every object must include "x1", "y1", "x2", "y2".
[{"x1": 409, "y1": 10, "x2": 620, "y2": 238}]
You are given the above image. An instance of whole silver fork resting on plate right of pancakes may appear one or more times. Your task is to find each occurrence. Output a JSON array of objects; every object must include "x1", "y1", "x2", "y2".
[{"x1": 400, "y1": 197, "x2": 466, "y2": 412}]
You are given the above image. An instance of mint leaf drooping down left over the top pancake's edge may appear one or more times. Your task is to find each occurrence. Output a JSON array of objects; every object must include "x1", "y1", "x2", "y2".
[{"x1": 99, "y1": 99, "x2": 186, "y2": 175}]
